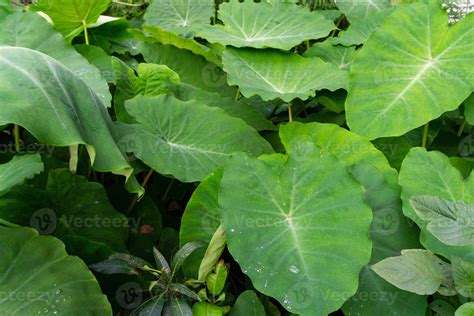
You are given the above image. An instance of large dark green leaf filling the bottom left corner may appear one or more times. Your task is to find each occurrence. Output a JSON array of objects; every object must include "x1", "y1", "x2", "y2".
[{"x1": 0, "y1": 227, "x2": 112, "y2": 316}]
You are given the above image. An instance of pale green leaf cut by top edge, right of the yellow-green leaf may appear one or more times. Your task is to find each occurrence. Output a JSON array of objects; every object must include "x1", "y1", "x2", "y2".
[{"x1": 145, "y1": 0, "x2": 214, "y2": 34}]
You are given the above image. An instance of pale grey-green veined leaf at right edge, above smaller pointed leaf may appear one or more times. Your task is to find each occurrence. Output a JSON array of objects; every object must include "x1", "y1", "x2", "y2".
[{"x1": 410, "y1": 195, "x2": 474, "y2": 246}]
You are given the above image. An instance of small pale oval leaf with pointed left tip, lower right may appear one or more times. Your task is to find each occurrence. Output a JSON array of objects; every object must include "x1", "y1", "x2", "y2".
[{"x1": 372, "y1": 249, "x2": 445, "y2": 295}]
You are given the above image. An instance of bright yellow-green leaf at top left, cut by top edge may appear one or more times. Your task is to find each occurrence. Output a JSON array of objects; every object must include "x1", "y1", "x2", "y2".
[{"x1": 32, "y1": 0, "x2": 111, "y2": 42}]
